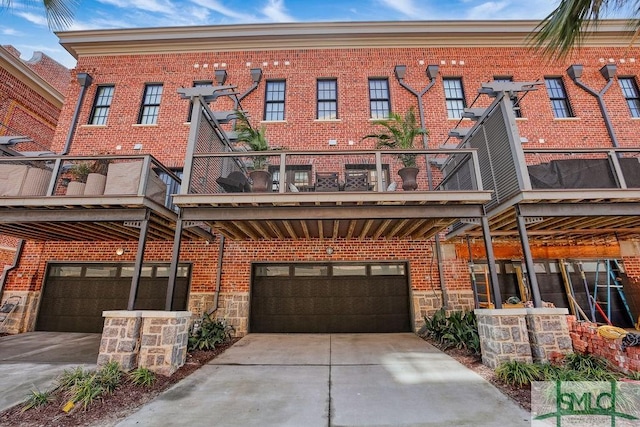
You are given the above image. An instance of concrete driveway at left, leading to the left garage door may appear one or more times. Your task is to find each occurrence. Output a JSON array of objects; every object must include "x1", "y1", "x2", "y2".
[{"x1": 0, "y1": 332, "x2": 101, "y2": 411}]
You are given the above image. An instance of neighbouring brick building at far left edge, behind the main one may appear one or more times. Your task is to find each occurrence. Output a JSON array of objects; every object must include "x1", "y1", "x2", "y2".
[{"x1": 0, "y1": 46, "x2": 71, "y2": 289}]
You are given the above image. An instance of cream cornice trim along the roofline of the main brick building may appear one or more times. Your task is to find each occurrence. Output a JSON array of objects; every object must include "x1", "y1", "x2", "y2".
[{"x1": 56, "y1": 20, "x2": 634, "y2": 59}]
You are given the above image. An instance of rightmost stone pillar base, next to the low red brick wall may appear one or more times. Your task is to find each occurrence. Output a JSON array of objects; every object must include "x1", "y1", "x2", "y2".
[{"x1": 526, "y1": 308, "x2": 573, "y2": 362}]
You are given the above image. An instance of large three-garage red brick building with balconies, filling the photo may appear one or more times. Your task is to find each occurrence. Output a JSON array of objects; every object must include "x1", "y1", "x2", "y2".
[{"x1": 0, "y1": 21, "x2": 640, "y2": 348}]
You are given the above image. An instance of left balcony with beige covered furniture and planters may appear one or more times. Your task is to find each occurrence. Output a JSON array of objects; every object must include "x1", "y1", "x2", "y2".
[{"x1": 0, "y1": 155, "x2": 208, "y2": 240}]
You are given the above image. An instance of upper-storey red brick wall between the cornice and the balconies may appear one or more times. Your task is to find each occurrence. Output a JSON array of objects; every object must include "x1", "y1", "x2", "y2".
[{"x1": 55, "y1": 48, "x2": 640, "y2": 165}]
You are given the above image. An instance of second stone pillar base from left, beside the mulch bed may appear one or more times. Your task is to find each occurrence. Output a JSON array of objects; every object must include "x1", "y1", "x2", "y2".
[{"x1": 139, "y1": 311, "x2": 191, "y2": 376}]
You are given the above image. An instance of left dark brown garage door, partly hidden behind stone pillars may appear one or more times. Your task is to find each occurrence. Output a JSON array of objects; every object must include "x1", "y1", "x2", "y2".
[{"x1": 36, "y1": 263, "x2": 190, "y2": 332}]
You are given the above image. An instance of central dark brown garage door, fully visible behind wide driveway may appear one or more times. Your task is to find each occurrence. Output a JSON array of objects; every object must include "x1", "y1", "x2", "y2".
[{"x1": 250, "y1": 264, "x2": 411, "y2": 333}]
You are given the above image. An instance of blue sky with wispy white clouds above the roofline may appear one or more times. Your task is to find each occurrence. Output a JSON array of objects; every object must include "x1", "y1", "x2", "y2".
[{"x1": 0, "y1": 0, "x2": 572, "y2": 68}]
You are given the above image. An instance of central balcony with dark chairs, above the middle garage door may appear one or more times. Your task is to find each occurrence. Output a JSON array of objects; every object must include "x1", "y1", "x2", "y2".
[{"x1": 173, "y1": 149, "x2": 491, "y2": 240}]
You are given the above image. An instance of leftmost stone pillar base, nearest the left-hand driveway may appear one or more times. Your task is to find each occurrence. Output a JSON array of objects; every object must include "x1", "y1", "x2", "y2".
[{"x1": 98, "y1": 310, "x2": 142, "y2": 372}]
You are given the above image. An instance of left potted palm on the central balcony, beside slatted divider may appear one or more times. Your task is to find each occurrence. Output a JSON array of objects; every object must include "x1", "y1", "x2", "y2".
[{"x1": 235, "y1": 110, "x2": 271, "y2": 192}]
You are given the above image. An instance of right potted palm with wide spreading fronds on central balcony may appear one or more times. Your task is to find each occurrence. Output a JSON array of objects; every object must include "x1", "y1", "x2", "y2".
[{"x1": 362, "y1": 107, "x2": 429, "y2": 191}]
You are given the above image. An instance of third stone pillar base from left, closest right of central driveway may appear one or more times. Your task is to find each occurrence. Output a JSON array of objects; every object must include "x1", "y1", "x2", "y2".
[{"x1": 474, "y1": 308, "x2": 532, "y2": 369}]
